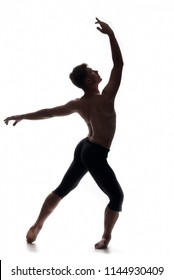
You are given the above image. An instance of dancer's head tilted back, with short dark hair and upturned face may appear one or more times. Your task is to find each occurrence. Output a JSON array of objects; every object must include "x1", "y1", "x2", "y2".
[{"x1": 69, "y1": 63, "x2": 102, "y2": 90}]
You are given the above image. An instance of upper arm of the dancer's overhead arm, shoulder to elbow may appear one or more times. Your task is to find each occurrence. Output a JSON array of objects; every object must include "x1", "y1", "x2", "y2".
[{"x1": 102, "y1": 64, "x2": 123, "y2": 97}]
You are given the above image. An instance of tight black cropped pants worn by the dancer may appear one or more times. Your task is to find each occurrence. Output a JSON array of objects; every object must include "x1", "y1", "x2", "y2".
[{"x1": 53, "y1": 138, "x2": 124, "y2": 211}]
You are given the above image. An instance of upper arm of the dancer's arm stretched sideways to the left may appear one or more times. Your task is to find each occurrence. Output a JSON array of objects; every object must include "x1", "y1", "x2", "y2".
[{"x1": 49, "y1": 99, "x2": 79, "y2": 117}]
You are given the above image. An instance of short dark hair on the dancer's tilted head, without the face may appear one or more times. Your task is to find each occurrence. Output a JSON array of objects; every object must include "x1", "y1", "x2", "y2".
[{"x1": 69, "y1": 63, "x2": 88, "y2": 89}]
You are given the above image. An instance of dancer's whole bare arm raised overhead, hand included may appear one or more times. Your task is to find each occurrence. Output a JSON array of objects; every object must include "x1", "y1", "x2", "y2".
[{"x1": 96, "y1": 18, "x2": 123, "y2": 97}]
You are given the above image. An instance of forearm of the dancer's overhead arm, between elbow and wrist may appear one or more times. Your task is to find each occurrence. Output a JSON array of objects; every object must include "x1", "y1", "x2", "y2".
[{"x1": 108, "y1": 31, "x2": 123, "y2": 66}]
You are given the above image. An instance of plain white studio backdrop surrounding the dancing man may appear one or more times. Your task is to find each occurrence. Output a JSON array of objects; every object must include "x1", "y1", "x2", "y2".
[{"x1": 0, "y1": 0, "x2": 174, "y2": 279}]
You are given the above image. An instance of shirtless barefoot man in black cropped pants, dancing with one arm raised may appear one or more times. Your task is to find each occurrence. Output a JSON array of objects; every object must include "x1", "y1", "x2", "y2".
[{"x1": 4, "y1": 18, "x2": 123, "y2": 249}]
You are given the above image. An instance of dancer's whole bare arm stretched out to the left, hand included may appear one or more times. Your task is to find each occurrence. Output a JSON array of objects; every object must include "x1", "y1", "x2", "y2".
[{"x1": 4, "y1": 99, "x2": 78, "y2": 126}]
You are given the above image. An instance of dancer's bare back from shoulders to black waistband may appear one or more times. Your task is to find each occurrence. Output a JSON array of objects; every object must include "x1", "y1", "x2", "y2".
[{"x1": 77, "y1": 94, "x2": 116, "y2": 149}]
